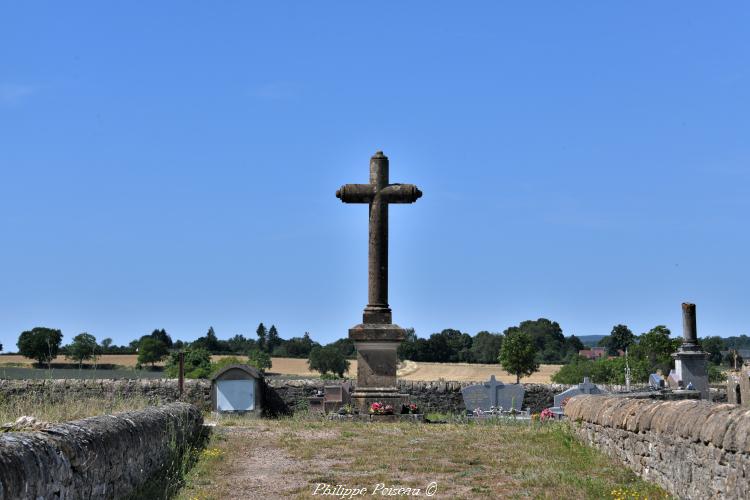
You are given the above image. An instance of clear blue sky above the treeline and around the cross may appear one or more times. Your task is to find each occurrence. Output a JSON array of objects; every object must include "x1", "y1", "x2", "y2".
[{"x1": 0, "y1": 1, "x2": 750, "y2": 350}]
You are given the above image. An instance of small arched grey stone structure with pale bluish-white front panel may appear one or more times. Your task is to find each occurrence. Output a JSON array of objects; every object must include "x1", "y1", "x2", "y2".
[{"x1": 211, "y1": 365, "x2": 263, "y2": 414}]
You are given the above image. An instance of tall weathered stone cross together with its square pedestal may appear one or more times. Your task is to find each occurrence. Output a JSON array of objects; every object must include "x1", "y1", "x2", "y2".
[{"x1": 336, "y1": 151, "x2": 422, "y2": 412}]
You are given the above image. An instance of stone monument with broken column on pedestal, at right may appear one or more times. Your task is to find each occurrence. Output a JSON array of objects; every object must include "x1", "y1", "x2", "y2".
[{"x1": 672, "y1": 303, "x2": 709, "y2": 399}]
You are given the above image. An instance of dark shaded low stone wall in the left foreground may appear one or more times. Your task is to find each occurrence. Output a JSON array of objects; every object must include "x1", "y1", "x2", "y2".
[{"x1": 0, "y1": 403, "x2": 203, "y2": 499}]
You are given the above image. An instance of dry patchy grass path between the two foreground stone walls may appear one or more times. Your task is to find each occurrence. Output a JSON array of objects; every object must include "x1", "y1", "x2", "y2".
[{"x1": 179, "y1": 418, "x2": 667, "y2": 499}]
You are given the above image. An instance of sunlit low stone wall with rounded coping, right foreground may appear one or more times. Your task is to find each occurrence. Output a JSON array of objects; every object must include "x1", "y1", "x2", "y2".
[{"x1": 565, "y1": 395, "x2": 750, "y2": 498}]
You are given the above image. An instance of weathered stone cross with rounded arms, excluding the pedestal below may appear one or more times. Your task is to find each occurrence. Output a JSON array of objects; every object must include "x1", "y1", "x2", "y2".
[{"x1": 336, "y1": 151, "x2": 422, "y2": 324}]
